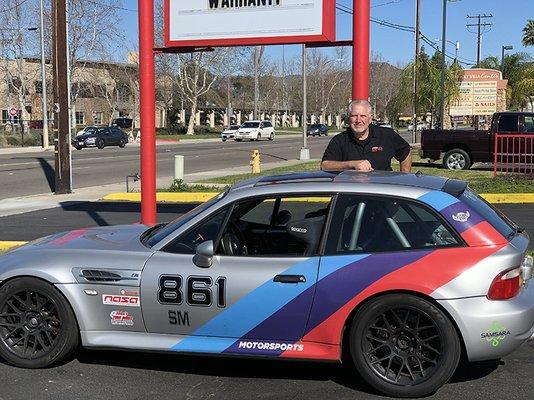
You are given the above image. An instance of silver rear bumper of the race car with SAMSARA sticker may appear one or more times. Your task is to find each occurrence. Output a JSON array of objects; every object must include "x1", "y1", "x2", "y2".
[{"x1": 439, "y1": 279, "x2": 534, "y2": 361}]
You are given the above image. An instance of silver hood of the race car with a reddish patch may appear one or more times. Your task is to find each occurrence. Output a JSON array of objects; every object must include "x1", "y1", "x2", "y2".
[{"x1": 14, "y1": 224, "x2": 149, "y2": 251}]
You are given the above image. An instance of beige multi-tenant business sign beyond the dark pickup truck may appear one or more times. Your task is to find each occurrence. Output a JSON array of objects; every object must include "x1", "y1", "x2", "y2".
[{"x1": 450, "y1": 68, "x2": 508, "y2": 116}]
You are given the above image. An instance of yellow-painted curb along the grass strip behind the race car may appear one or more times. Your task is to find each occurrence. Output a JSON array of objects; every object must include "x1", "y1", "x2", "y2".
[{"x1": 102, "y1": 192, "x2": 534, "y2": 204}]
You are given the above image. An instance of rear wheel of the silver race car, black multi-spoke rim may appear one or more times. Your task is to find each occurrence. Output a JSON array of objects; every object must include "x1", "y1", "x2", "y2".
[{"x1": 349, "y1": 294, "x2": 461, "y2": 397}]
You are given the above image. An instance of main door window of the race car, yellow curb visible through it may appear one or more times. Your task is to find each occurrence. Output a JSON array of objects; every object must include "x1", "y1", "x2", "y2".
[{"x1": 217, "y1": 196, "x2": 332, "y2": 257}]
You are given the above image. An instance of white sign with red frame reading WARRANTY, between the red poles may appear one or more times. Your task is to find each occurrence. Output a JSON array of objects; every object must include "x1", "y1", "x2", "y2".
[{"x1": 164, "y1": 0, "x2": 336, "y2": 47}]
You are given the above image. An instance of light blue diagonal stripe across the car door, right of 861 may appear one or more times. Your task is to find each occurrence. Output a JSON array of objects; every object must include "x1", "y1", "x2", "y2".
[{"x1": 173, "y1": 257, "x2": 319, "y2": 351}]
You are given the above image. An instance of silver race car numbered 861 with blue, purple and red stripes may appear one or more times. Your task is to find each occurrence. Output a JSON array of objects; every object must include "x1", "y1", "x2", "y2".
[{"x1": 0, "y1": 171, "x2": 534, "y2": 397}]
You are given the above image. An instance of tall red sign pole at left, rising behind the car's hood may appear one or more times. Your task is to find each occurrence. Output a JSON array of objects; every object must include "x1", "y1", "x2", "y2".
[{"x1": 138, "y1": 0, "x2": 156, "y2": 225}]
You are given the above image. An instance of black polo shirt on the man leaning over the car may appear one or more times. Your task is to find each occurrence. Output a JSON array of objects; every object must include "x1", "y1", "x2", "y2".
[{"x1": 323, "y1": 125, "x2": 410, "y2": 171}]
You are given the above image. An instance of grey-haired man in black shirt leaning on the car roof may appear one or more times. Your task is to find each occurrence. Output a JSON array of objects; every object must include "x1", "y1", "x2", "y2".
[{"x1": 321, "y1": 100, "x2": 412, "y2": 172}]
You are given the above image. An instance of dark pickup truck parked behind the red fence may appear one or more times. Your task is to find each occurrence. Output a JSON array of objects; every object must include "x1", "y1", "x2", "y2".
[{"x1": 419, "y1": 112, "x2": 534, "y2": 169}]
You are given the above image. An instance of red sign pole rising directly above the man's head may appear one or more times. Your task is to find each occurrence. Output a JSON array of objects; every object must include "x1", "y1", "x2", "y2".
[{"x1": 352, "y1": 0, "x2": 371, "y2": 100}]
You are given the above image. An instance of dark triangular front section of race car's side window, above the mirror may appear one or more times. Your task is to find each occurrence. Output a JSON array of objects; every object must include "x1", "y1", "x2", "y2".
[{"x1": 163, "y1": 208, "x2": 228, "y2": 254}]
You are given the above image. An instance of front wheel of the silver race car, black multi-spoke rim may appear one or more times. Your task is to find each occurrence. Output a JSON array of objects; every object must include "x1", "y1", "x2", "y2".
[{"x1": 0, "y1": 278, "x2": 79, "y2": 368}]
